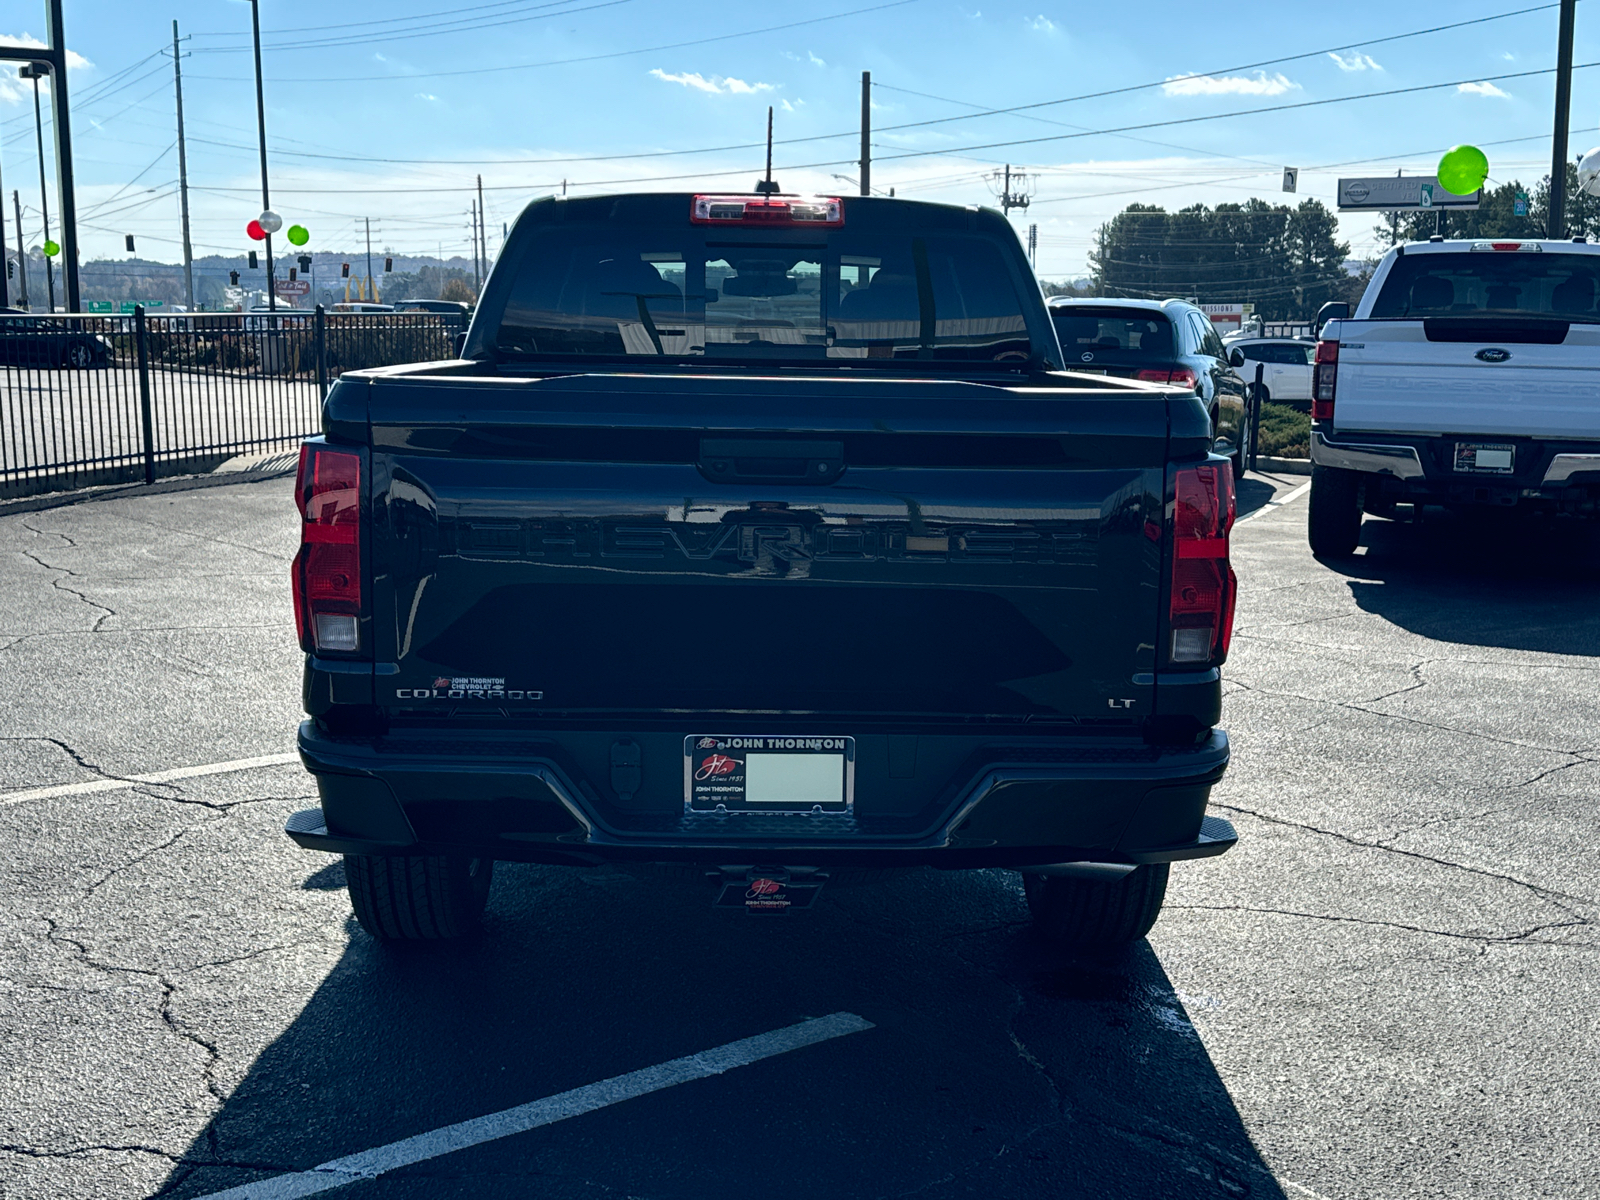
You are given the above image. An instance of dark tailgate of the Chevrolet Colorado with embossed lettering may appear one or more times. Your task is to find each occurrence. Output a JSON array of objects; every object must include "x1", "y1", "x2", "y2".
[{"x1": 368, "y1": 374, "x2": 1168, "y2": 725}]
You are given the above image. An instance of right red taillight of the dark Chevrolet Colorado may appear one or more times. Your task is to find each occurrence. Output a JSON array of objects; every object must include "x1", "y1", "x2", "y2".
[{"x1": 1168, "y1": 462, "x2": 1238, "y2": 664}]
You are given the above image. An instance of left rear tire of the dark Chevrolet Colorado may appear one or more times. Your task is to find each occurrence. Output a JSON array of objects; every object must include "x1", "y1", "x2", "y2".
[{"x1": 344, "y1": 854, "x2": 494, "y2": 942}]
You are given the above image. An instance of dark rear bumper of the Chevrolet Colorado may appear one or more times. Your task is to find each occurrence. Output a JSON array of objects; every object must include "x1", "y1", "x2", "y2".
[{"x1": 285, "y1": 722, "x2": 1237, "y2": 867}]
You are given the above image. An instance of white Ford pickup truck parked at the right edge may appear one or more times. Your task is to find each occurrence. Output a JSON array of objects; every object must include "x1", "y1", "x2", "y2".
[{"x1": 1309, "y1": 240, "x2": 1600, "y2": 557}]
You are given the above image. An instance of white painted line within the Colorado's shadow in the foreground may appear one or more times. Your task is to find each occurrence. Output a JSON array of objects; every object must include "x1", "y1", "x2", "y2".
[{"x1": 200, "y1": 1013, "x2": 872, "y2": 1200}]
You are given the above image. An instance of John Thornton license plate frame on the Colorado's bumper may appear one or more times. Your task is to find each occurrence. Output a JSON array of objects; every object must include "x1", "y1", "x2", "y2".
[{"x1": 683, "y1": 733, "x2": 856, "y2": 814}]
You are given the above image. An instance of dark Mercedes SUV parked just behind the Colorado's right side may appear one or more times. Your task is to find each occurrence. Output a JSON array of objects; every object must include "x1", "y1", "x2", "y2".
[{"x1": 1050, "y1": 296, "x2": 1250, "y2": 478}]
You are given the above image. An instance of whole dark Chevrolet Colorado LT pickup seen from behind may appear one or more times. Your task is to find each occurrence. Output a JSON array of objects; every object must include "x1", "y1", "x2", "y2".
[{"x1": 286, "y1": 192, "x2": 1237, "y2": 944}]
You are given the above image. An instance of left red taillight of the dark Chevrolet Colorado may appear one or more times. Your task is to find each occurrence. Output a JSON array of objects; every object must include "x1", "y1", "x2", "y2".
[{"x1": 290, "y1": 443, "x2": 362, "y2": 651}]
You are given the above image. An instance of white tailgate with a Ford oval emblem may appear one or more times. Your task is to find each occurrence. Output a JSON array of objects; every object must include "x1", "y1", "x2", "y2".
[{"x1": 1325, "y1": 318, "x2": 1600, "y2": 438}]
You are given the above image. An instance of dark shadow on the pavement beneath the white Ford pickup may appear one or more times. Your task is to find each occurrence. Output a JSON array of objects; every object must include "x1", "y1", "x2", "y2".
[{"x1": 1325, "y1": 512, "x2": 1600, "y2": 658}]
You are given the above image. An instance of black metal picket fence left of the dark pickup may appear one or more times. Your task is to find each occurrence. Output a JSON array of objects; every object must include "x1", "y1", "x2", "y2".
[{"x1": 0, "y1": 307, "x2": 466, "y2": 496}]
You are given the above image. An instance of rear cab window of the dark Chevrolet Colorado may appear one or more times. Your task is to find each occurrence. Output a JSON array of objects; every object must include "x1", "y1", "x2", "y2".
[{"x1": 494, "y1": 195, "x2": 1036, "y2": 368}]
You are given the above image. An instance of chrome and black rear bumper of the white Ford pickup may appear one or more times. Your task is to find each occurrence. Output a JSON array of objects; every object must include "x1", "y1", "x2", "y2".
[{"x1": 1310, "y1": 422, "x2": 1600, "y2": 514}]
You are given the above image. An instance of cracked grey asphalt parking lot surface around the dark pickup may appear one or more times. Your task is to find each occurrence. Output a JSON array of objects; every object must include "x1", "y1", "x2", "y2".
[{"x1": 0, "y1": 477, "x2": 1600, "y2": 1200}]
